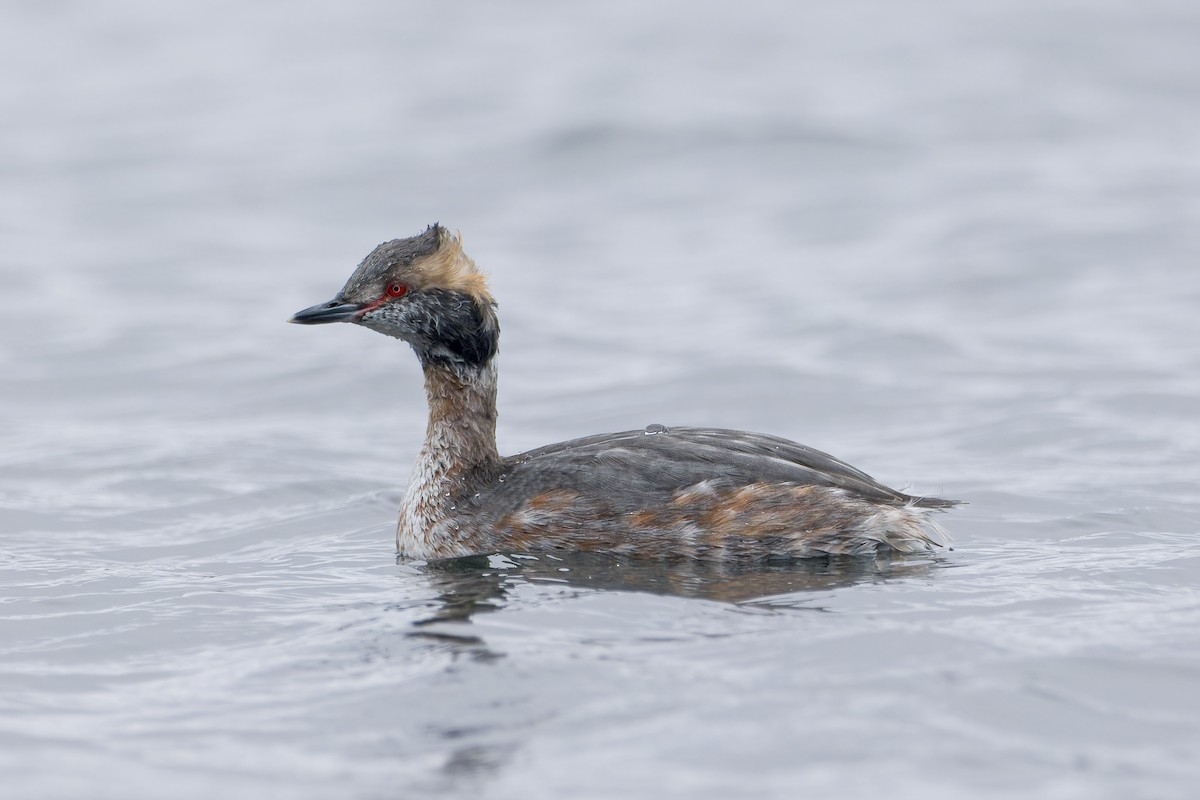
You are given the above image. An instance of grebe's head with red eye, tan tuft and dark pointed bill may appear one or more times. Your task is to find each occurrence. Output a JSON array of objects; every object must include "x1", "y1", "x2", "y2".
[{"x1": 290, "y1": 223, "x2": 499, "y2": 368}]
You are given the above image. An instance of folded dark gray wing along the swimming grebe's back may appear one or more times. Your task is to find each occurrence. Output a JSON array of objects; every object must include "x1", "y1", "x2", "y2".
[{"x1": 496, "y1": 427, "x2": 955, "y2": 509}]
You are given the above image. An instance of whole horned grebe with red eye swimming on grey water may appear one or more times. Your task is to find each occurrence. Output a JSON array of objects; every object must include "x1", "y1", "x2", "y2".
[{"x1": 290, "y1": 224, "x2": 956, "y2": 559}]
